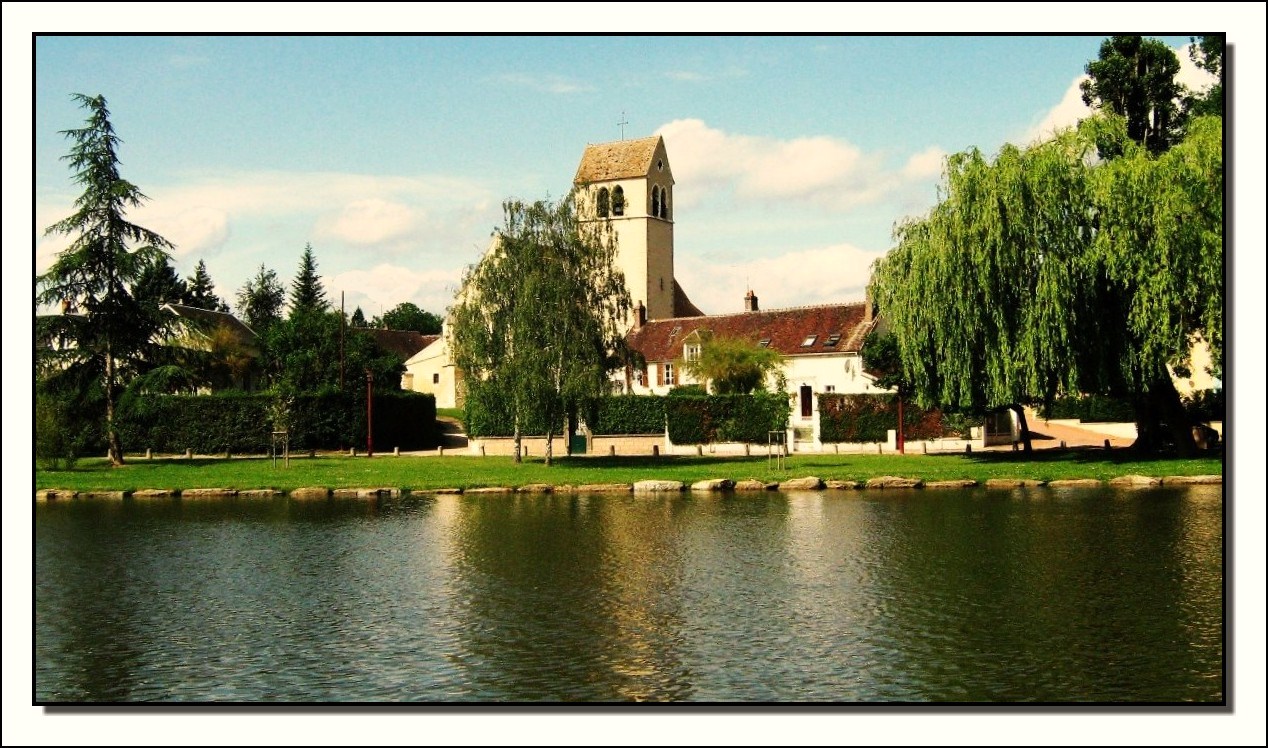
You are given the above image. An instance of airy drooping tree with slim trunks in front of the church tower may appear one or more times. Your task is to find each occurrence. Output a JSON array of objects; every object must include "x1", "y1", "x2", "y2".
[{"x1": 450, "y1": 194, "x2": 630, "y2": 465}]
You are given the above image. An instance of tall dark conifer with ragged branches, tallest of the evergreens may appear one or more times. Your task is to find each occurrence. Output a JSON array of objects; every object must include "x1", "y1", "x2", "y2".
[{"x1": 36, "y1": 94, "x2": 171, "y2": 464}]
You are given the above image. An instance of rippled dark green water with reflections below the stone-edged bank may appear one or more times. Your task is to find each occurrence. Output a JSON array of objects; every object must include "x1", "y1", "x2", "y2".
[{"x1": 34, "y1": 486, "x2": 1225, "y2": 704}]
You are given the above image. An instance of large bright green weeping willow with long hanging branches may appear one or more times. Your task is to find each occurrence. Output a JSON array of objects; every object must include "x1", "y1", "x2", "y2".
[{"x1": 872, "y1": 115, "x2": 1224, "y2": 449}]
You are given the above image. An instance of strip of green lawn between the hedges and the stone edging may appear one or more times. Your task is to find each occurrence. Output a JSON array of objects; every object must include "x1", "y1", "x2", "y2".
[{"x1": 36, "y1": 450, "x2": 1224, "y2": 499}]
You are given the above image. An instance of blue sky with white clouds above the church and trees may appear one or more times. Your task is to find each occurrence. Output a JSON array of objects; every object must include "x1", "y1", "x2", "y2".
[{"x1": 22, "y1": 22, "x2": 1237, "y2": 316}]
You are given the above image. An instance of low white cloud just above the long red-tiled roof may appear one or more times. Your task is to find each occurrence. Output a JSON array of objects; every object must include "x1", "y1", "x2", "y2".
[{"x1": 673, "y1": 243, "x2": 885, "y2": 314}]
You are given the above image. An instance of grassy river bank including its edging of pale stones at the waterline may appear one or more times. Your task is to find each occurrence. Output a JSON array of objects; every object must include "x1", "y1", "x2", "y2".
[{"x1": 34, "y1": 450, "x2": 1224, "y2": 498}]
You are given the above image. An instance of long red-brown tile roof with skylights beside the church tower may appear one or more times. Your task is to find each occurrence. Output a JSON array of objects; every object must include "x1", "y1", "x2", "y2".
[{"x1": 625, "y1": 302, "x2": 872, "y2": 361}]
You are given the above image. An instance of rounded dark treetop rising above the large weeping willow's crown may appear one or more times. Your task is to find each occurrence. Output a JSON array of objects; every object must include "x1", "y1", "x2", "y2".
[{"x1": 1079, "y1": 35, "x2": 1183, "y2": 158}]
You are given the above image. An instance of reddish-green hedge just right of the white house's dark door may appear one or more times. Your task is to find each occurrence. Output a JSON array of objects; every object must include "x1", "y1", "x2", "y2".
[{"x1": 819, "y1": 393, "x2": 962, "y2": 444}]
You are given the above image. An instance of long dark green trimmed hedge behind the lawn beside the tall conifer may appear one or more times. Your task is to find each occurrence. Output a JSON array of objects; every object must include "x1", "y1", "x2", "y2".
[{"x1": 118, "y1": 392, "x2": 437, "y2": 454}]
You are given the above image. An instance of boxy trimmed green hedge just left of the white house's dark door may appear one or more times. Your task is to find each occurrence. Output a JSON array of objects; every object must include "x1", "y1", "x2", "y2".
[{"x1": 664, "y1": 393, "x2": 790, "y2": 444}]
